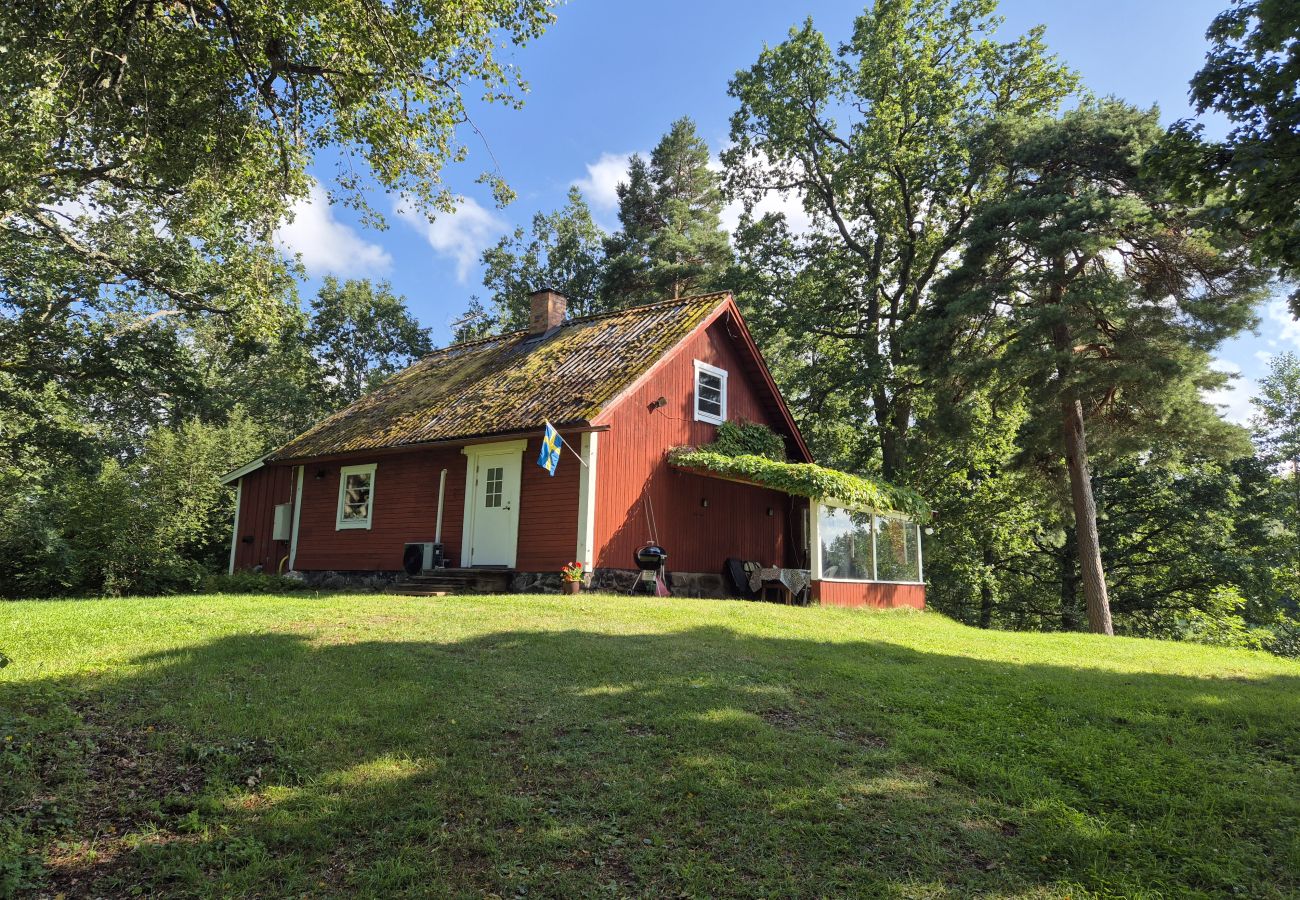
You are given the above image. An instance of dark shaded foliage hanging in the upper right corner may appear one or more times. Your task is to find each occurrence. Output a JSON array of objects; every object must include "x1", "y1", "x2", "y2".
[{"x1": 1162, "y1": 0, "x2": 1300, "y2": 309}]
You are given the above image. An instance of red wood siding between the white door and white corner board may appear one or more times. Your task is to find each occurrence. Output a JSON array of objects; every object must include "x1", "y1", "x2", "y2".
[{"x1": 515, "y1": 429, "x2": 579, "y2": 572}]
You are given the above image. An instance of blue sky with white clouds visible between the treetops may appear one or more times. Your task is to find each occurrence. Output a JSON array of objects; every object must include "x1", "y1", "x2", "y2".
[{"x1": 271, "y1": 0, "x2": 1300, "y2": 420}]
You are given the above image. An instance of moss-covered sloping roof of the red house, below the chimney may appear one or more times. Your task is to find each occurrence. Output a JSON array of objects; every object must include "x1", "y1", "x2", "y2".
[{"x1": 267, "y1": 293, "x2": 729, "y2": 462}]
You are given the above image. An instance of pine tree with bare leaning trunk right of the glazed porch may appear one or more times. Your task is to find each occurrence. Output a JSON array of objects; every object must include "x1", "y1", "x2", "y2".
[{"x1": 918, "y1": 100, "x2": 1261, "y2": 635}]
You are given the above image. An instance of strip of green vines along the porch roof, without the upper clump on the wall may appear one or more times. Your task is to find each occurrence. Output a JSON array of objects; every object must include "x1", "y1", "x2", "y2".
[{"x1": 668, "y1": 447, "x2": 930, "y2": 519}]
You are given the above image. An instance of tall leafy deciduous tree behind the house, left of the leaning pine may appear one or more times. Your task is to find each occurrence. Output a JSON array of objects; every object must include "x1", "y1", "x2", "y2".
[{"x1": 723, "y1": 0, "x2": 1075, "y2": 479}]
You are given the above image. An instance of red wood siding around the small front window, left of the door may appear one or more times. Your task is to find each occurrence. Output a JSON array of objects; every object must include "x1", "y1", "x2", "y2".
[{"x1": 296, "y1": 447, "x2": 465, "y2": 572}]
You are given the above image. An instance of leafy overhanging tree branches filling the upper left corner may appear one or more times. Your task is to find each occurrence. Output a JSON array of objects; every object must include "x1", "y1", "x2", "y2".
[{"x1": 0, "y1": 0, "x2": 551, "y2": 499}]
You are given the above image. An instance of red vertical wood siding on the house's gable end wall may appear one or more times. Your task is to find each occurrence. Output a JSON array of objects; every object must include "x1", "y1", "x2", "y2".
[{"x1": 595, "y1": 317, "x2": 803, "y2": 572}]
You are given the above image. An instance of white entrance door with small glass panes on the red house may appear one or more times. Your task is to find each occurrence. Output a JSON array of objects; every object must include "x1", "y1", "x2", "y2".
[{"x1": 464, "y1": 441, "x2": 523, "y2": 566}]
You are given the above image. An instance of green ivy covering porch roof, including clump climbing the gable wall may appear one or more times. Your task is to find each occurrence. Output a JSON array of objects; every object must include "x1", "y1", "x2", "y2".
[{"x1": 668, "y1": 421, "x2": 930, "y2": 518}]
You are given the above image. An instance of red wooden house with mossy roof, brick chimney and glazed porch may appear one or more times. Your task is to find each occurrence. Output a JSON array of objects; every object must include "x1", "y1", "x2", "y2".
[{"x1": 225, "y1": 290, "x2": 924, "y2": 606}]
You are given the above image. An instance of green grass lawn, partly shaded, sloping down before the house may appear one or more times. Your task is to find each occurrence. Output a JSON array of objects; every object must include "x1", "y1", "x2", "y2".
[{"x1": 0, "y1": 596, "x2": 1300, "y2": 897}]
